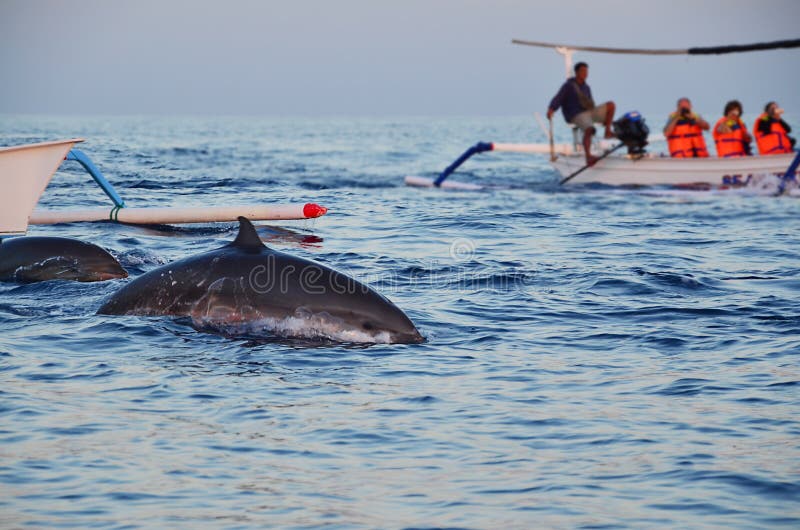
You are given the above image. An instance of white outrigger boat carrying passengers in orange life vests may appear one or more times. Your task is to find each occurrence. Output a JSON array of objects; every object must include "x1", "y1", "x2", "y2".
[{"x1": 405, "y1": 39, "x2": 800, "y2": 193}]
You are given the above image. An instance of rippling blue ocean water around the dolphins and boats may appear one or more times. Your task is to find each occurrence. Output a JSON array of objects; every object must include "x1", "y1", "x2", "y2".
[{"x1": 0, "y1": 116, "x2": 800, "y2": 529}]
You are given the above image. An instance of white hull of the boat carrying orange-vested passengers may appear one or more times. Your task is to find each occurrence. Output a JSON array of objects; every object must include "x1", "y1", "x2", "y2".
[{"x1": 552, "y1": 153, "x2": 796, "y2": 187}]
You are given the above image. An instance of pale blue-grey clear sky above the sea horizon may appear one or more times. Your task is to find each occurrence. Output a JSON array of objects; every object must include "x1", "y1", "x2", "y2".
[{"x1": 0, "y1": 0, "x2": 800, "y2": 117}]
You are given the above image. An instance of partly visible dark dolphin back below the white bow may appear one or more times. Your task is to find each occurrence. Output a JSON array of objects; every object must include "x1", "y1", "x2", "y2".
[{"x1": 0, "y1": 236, "x2": 128, "y2": 283}]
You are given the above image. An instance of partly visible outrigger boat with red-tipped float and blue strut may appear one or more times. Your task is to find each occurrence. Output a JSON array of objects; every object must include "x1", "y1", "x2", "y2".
[{"x1": 0, "y1": 138, "x2": 328, "y2": 236}]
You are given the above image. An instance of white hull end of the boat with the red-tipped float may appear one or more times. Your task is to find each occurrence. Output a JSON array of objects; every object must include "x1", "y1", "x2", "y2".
[{"x1": 0, "y1": 138, "x2": 83, "y2": 235}]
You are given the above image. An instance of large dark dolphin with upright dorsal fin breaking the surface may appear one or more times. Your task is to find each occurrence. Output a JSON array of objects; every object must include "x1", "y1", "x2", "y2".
[{"x1": 97, "y1": 217, "x2": 424, "y2": 343}]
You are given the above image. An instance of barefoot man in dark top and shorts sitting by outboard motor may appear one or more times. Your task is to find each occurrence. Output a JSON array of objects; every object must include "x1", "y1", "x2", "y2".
[{"x1": 547, "y1": 62, "x2": 616, "y2": 166}]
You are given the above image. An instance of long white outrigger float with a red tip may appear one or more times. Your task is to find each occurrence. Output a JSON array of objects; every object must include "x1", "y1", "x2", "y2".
[{"x1": 29, "y1": 203, "x2": 328, "y2": 225}]
